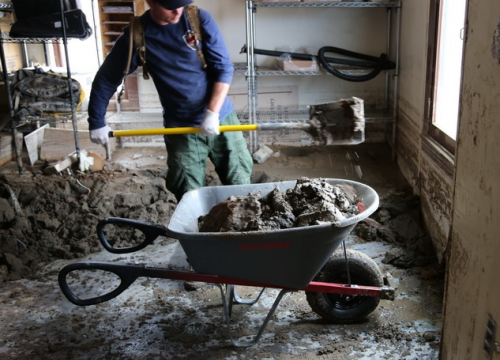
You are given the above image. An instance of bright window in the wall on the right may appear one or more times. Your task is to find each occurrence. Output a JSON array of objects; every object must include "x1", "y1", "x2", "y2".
[{"x1": 426, "y1": 0, "x2": 467, "y2": 153}]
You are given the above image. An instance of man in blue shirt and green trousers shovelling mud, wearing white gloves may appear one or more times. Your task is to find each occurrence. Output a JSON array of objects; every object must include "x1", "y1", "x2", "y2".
[{"x1": 88, "y1": 0, "x2": 253, "y2": 201}]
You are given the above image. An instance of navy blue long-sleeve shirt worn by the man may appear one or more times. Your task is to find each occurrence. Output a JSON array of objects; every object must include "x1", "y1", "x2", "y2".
[{"x1": 88, "y1": 9, "x2": 234, "y2": 130}]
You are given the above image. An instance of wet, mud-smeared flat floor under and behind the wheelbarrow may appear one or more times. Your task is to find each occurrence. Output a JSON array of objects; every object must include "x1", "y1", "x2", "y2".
[{"x1": 0, "y1": 144, "x2": 443, "y2": 360}]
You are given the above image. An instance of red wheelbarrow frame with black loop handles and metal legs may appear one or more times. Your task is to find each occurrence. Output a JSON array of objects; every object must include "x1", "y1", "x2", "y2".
[{"x1": 58, "y1": 212, "x2": 395, "y2": 347}]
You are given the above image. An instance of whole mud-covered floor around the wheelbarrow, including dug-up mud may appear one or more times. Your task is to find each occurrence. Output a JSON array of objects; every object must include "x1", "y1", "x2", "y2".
[{"x1": 0, "y1": 144, "x2": 443, "y2": 360}]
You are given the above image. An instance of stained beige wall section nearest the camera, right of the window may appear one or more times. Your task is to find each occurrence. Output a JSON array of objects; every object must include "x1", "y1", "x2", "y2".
[{"x1": 441, "y1": 0, "x2": 500, "y2": 360}]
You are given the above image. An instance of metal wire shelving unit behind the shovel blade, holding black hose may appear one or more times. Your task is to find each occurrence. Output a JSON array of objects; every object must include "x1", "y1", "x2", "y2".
[{"x1": 244, "y1": 0, "x2": 401, "y2": 156}]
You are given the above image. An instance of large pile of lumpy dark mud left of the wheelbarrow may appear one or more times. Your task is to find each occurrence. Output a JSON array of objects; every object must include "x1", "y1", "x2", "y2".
[{"x1": 0, "y1": 170, "x2": 177, "y2": 283}]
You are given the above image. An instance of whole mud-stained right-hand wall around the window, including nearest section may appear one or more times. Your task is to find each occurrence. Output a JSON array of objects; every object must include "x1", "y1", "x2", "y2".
[{"x1": 397, "y1": 0, "x2": 500, "y2": 360}]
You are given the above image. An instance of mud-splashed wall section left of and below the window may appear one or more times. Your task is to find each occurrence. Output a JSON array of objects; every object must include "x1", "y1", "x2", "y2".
[{"x1": 396, "y1": 0, "x2": 454, "y2": 261}]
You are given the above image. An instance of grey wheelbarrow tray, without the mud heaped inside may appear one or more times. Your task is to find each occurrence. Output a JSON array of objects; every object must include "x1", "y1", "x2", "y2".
[{"x1": 168, "y1": 179, "x2": 379, "y2": 289}]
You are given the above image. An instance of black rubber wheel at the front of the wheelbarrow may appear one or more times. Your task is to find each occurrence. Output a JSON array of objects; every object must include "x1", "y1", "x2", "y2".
[{"x1": 306, "y1": 250, "x2": 384, "y2": 324}]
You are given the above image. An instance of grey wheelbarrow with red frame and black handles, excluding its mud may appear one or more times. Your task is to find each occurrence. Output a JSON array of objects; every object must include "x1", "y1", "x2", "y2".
[{"x1": 58, "y1": 179, "x2": 395, "y2": 347}]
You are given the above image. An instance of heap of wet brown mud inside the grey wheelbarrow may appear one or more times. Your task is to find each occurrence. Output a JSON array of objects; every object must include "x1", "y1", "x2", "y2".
[{"x1": 198, "y1": 178, "x2": 364, "y2": 232}]
